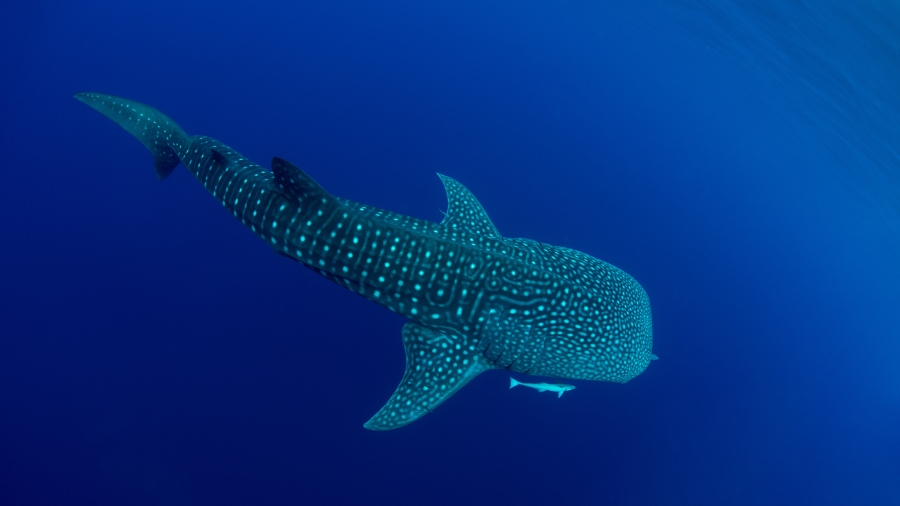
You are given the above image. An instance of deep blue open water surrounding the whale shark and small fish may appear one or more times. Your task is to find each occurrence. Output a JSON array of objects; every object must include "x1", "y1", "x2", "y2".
[{"x1": 0, "y1": 0, "x2": 900, "y2": 505}]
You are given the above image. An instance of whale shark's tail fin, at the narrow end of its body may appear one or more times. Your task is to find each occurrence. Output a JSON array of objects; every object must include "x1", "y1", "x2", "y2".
[{"x1": 75, "y1": 93, "x2": 190, "y2": 179}]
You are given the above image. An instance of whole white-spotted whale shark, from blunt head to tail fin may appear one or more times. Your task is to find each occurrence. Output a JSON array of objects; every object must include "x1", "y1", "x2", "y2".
[{"x1": 76, "y1": 93, "x2": 652, "y2": 430}]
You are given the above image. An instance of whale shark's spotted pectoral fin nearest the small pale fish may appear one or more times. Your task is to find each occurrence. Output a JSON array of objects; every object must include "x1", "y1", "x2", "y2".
[{"x1": 365, "y1": 322, "x2": 490, "y2": 430}]
